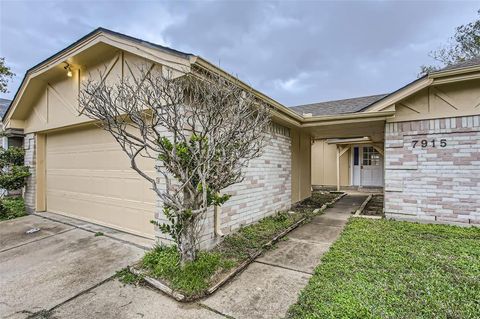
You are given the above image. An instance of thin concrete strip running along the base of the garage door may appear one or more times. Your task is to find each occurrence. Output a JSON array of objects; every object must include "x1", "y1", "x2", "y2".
[{"x1": 37, "y1": 212, "x2": 155, "y2": 249}]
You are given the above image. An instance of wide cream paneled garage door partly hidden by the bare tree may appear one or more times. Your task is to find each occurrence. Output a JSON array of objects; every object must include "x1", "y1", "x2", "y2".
[{"x1": 46, "y1": 127, "x2": 155, "y2": 237}]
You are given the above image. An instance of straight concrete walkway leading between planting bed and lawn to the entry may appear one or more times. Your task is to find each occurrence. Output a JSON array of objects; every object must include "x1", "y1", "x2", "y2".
[{"x1": 200, "y1": 194, "x2": 367, "y2": 319}]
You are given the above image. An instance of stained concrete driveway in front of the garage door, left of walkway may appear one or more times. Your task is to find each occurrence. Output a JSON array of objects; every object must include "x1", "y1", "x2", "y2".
[{"x1": 0, "y1": 213, "x2": 224, "y2": 319}]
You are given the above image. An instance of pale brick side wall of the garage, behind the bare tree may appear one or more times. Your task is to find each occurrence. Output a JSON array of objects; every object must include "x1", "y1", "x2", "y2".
[{"x1": 156, "y1": 130, "x2": 291, "y2": 249}]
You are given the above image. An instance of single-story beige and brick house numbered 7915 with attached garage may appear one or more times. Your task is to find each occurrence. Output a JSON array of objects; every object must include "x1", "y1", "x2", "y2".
[{"x1": 3, "y1": 28, "x2": 480, "y2": 247}]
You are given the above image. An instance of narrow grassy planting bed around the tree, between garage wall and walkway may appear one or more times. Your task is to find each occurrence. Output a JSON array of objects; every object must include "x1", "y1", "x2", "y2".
[{"x1": 118, "y1": 193, "x2": 338, "y2": 298}]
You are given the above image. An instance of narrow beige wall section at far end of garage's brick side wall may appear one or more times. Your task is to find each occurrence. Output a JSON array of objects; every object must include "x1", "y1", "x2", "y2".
[{"x1": 291, "y1": 129, "x2": 312, "y2": 203}]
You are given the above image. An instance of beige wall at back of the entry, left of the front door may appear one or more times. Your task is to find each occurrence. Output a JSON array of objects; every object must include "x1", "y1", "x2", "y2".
[{"x1": 311, "y1": 140, "x2": 350, "y2": 186}]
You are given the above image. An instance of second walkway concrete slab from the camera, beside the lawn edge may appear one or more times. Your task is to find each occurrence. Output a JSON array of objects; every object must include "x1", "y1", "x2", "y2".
[{"x1": 256, "y1": 239, "x2": 330, "y2": 274}]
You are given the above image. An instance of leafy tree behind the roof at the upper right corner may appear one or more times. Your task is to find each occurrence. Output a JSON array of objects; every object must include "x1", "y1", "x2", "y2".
[{"x1": 419, "y1": 10, "x2": 480, "y2": 76}]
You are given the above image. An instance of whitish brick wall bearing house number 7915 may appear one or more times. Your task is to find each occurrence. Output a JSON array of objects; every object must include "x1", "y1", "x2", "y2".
[{"x1": 385, "y1": 115, "x2": 480, "y2": 225}]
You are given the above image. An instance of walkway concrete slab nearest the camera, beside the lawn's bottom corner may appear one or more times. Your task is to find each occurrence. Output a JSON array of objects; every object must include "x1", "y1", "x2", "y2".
[{"x1": 202, "y1": 263, "x2": 310, "y2": 319}]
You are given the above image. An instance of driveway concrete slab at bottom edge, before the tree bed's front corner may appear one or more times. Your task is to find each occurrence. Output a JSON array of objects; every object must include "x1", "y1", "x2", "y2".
[{"x1": 51, "y1": 280, "x2": 224, "y2": 319}]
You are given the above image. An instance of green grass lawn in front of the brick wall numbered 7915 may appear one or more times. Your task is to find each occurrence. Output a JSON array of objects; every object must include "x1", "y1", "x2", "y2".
[{"x1": 288, "y1": 218, "x2": 480, "y2": 318}]
